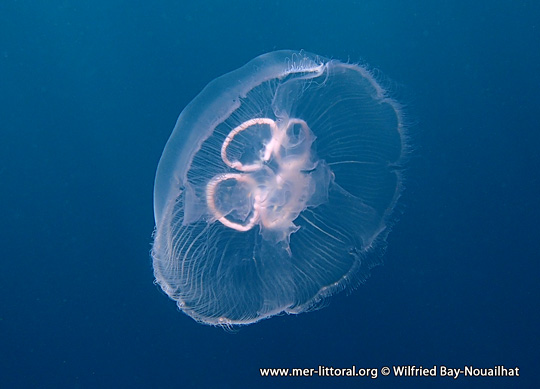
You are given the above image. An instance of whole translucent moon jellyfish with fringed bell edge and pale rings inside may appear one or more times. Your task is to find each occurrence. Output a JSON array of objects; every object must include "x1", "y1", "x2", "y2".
[{"x1": 152, "y1": 51, "x2": 406, "y2": 326}]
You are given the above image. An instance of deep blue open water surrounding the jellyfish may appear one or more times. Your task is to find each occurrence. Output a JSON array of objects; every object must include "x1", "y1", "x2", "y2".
[{"x1": 0, "y1": 0, "x2": 540, "y2": 388}]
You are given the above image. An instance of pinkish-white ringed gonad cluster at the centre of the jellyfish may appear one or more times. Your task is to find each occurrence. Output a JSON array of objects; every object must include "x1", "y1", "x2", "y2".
[{"x1": 206, "y1": 118, "x2": 314, "y2": 231}]
